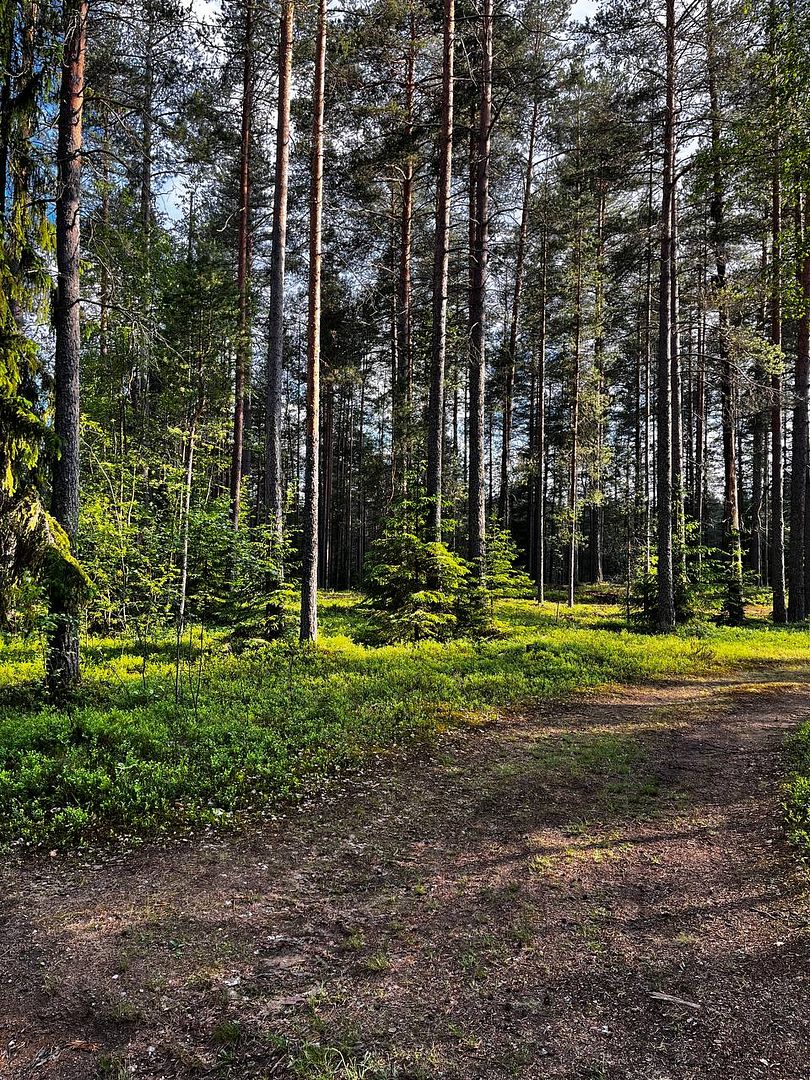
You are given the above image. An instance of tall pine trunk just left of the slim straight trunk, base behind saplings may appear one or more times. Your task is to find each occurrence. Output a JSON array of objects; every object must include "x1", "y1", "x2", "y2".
[{"x1": 265, "y1": 0, "x2": 295, "y2": 556}]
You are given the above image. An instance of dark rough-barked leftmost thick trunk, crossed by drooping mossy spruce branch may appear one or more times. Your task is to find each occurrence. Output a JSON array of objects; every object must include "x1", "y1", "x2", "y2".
[{"x1": 46, "y1": 0, "x2": 87, "y2": 692}]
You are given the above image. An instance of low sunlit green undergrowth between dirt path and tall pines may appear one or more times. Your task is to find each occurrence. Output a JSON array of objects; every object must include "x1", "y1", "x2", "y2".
[{"x1": 0, "y1": 594, "x2": 810, "y2": 847}]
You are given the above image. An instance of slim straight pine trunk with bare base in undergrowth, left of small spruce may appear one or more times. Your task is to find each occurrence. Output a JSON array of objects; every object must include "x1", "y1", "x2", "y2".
[{"x1": 300, "y1": 0, "x2": 326, "y2": 642}]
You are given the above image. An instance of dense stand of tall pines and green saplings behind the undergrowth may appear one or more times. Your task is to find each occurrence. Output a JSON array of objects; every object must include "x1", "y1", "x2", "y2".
[{"x1": 0, "y1": 0, "x2": 810, "y2": 686}]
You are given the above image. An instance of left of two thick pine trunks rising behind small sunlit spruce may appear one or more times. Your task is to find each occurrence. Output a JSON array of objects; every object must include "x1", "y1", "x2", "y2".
[{"x1": 426, "y1": 0, "x2": 456, "y2": 541}]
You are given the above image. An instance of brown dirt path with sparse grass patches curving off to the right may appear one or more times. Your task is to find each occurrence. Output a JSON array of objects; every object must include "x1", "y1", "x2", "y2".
[{"x1": 0, "y1": 671, "x2": 810, "y2": 1080}]
